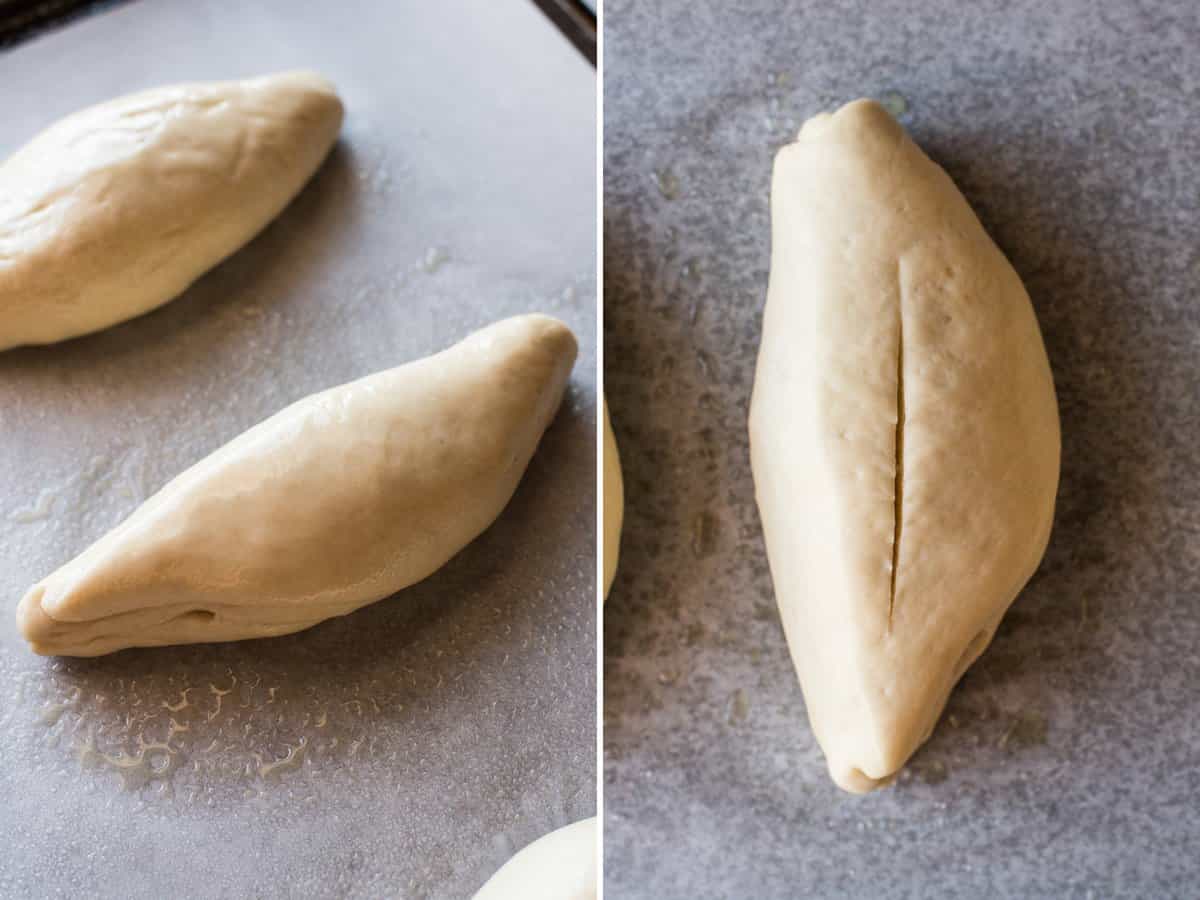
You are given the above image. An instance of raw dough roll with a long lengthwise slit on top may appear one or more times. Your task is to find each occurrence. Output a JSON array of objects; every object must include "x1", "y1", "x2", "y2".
[{"x1": 750, "y1": 101, "x2": 1060, "y2": 792}]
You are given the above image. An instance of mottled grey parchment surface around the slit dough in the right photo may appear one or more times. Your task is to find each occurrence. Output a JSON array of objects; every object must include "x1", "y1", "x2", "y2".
[{"x1": 604, "y1": 0, "x2": 1200, "y2": 900}]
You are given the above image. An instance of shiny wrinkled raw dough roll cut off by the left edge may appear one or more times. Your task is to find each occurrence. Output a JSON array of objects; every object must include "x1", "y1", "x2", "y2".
[{"x1": 0, "y1": 72, "x2": 342, "y2": 350}]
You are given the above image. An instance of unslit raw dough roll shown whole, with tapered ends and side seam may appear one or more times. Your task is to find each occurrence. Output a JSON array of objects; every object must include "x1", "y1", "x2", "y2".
[{"x1": 17, "y1": 316, "x2": 576, "y2": 656}]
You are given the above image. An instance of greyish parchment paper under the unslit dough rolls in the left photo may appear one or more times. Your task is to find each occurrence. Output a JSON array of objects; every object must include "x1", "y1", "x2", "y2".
[{"x1": 0, "y1": 0, "x2": 596, "y2": 900}]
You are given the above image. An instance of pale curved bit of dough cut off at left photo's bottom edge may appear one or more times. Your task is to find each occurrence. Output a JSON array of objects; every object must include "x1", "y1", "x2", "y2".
[{"x1": 474, "y1": 818, "x2": 598, "y2": 900}]
